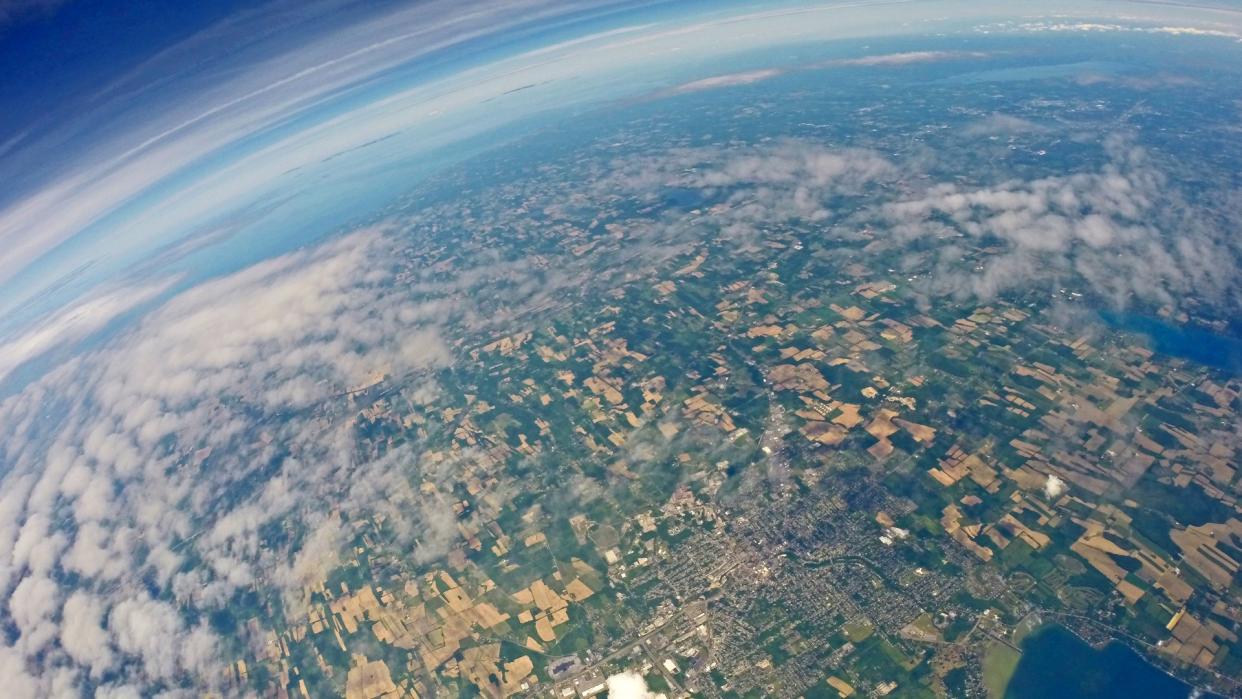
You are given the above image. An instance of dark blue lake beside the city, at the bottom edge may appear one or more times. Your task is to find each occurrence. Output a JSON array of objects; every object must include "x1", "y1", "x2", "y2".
[{"x1": 1005, "y1": 626, "x2": 1212, "y2": 699}]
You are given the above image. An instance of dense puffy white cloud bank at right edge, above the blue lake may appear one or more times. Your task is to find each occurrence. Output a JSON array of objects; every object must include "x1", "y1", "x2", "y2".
[{"x1": 881, "y1": 135, "x2": 1240, "y2": 308}]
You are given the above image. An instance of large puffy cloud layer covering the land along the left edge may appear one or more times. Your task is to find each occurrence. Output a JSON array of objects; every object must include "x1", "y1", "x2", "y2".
[{"x1": 0, "y1": 230, "x2": 462, "y2": 695}]
